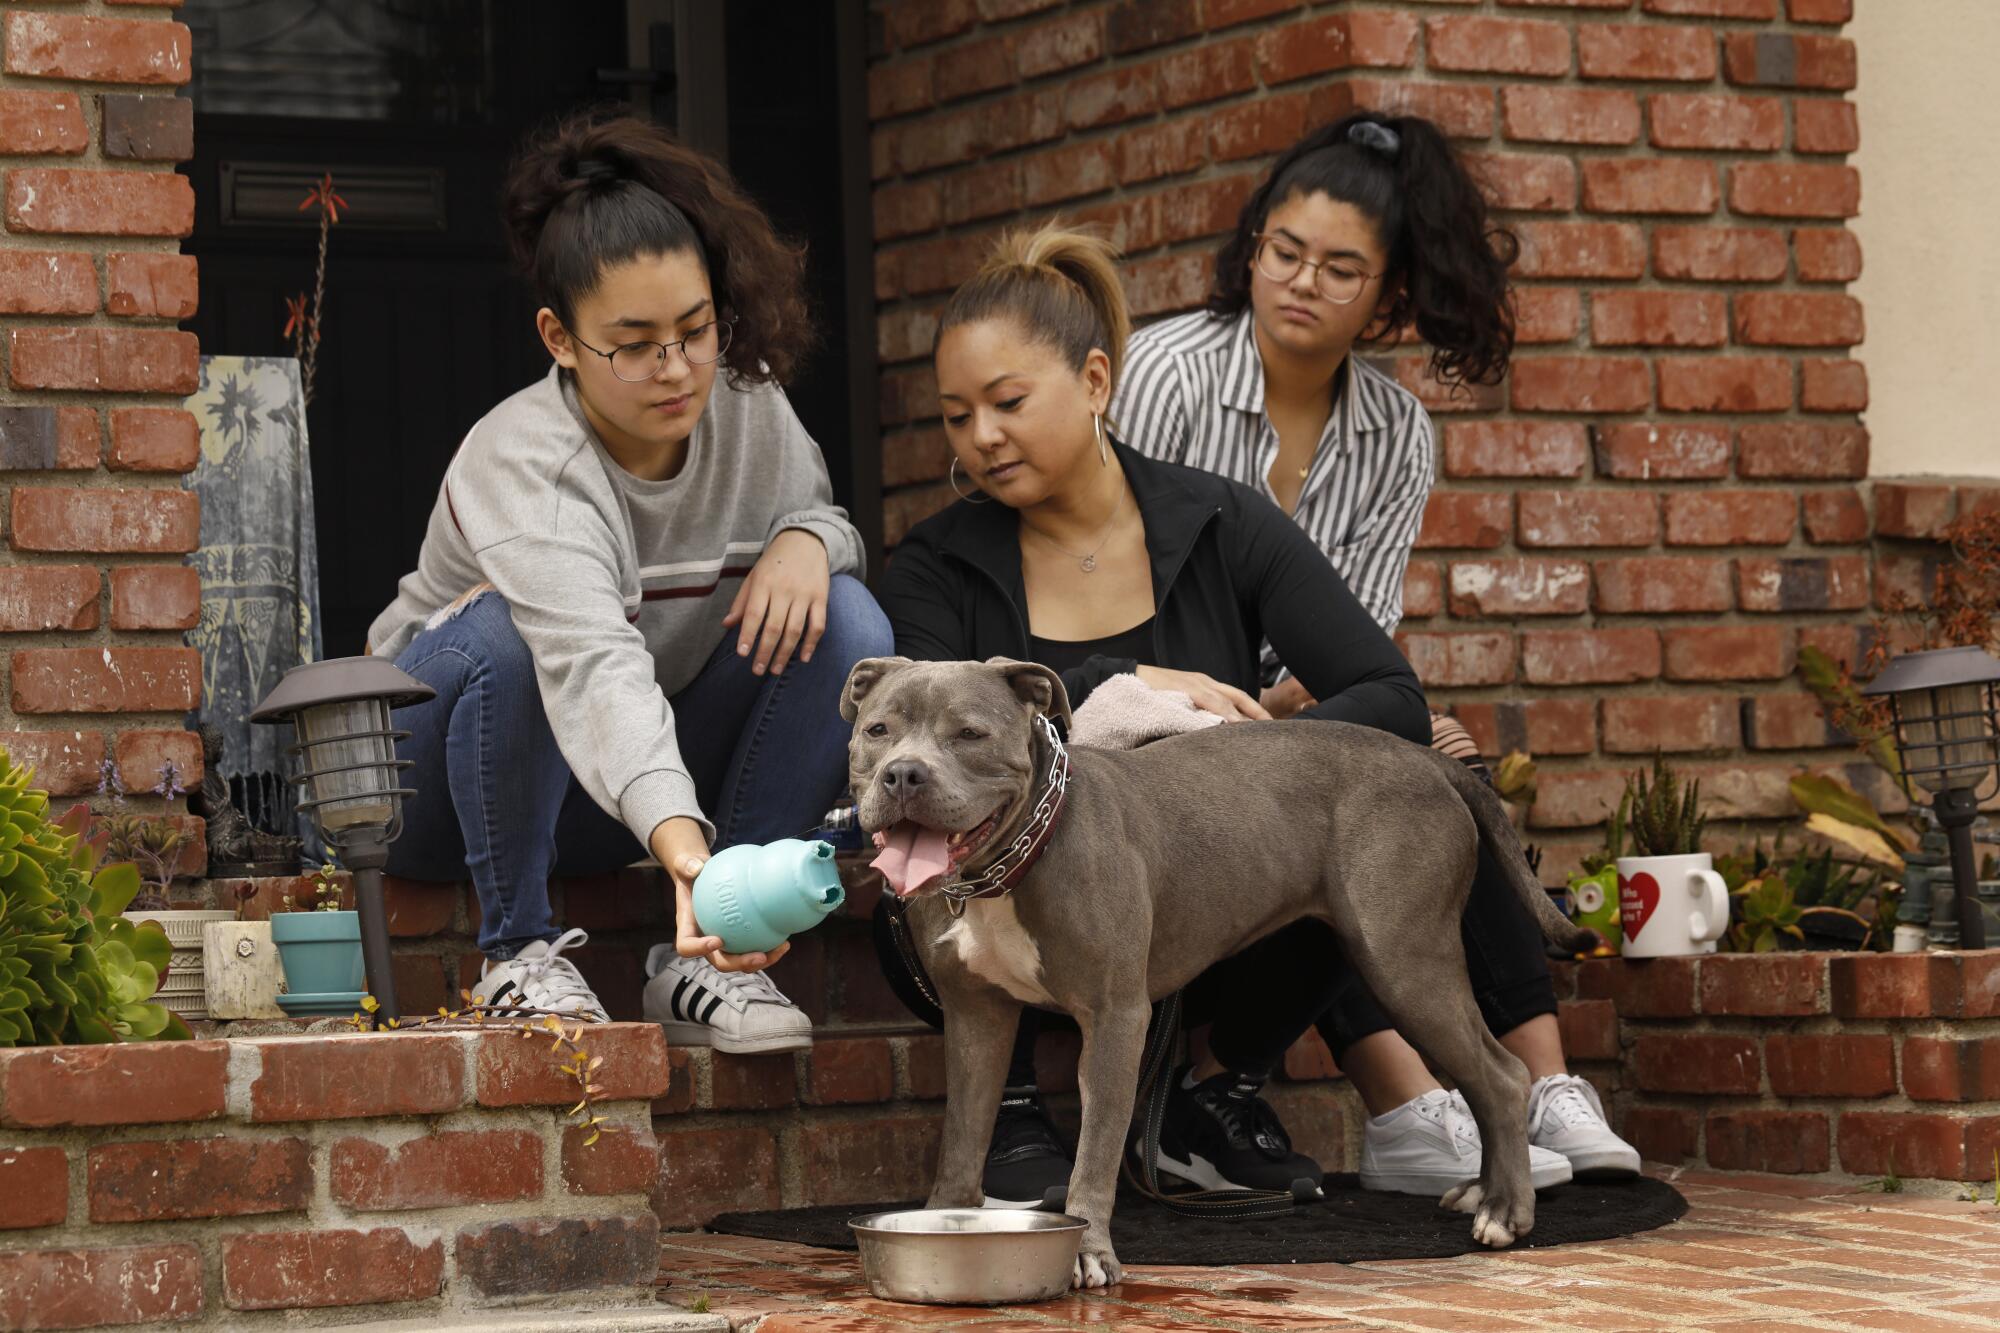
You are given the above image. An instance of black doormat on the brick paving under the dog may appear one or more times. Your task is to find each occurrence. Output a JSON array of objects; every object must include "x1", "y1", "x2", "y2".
[{"x1": 708, "y1": 1175, "x2": 1688, "y2": 1265}]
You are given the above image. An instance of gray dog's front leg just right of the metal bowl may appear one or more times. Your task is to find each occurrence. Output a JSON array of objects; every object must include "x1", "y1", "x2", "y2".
[{"x1": 1068, "y1": 995, "x2": 1152, "y2": 1287}]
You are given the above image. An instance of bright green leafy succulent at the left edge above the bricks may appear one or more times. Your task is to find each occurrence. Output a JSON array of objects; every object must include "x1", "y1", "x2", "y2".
[{"x1": 0, "y1": 747, "x2": 190, "y2": 1047}]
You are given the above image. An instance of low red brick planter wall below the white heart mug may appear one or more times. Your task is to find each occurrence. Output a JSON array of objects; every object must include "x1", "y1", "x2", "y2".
[{"x1": 1556, "y1": 953, "x2": 2000, "y2": 1183}]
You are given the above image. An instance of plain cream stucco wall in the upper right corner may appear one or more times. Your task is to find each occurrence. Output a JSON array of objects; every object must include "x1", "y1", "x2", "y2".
[{"x1": 1846, "y1": 0, "x2": 2000, "y2": 476}]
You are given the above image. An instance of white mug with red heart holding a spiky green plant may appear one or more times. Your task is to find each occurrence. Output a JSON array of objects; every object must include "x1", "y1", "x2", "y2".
[{"x1": 1618, "y1": 755, "x2": 1730, "y2": 959}]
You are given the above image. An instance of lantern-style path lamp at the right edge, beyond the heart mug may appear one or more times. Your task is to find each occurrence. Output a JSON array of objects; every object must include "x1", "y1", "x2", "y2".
[{"x1": 1862, "y1": 648, "x2": 2000, "y2": 949}]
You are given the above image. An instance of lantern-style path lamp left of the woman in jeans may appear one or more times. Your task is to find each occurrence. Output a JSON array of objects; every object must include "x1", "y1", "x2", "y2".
[{"x1": 250, "y1": 656, "x2": 436, "y2": 1025}]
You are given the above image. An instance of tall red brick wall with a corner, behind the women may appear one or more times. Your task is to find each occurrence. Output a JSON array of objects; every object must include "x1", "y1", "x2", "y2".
[{"x1": 870, "y1": 0, "x2": 1874, "y2": 873}]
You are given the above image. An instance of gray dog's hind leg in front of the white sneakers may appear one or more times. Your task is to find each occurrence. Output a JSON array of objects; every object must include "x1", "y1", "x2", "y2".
[{"x1": 1356, "y1": 931, "x2": 1534, "y2": 1249}]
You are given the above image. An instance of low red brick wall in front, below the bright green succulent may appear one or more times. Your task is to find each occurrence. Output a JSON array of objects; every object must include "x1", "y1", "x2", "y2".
[{"x1": 0, "y1": 1023, "x2": 676, "y2": 1329}]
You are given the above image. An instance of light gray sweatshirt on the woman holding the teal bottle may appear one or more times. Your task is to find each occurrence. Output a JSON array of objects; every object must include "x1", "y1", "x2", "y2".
[{"x1": 368, "y1": 366, "x2": 862, "y2": 845}]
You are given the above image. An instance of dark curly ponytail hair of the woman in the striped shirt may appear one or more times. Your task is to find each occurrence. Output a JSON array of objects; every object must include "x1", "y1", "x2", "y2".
[{"x1": 1208, "y1": 110, "x2": 1520, "y2": 384}]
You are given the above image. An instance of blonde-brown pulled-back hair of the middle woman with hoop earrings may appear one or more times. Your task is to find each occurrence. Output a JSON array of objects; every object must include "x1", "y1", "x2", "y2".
[{"x1": 930, "y1": 222, "x2": 1132, "y2": 418}]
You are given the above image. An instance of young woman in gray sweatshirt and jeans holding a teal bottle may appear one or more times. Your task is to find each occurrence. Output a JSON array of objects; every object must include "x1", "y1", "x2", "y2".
[{"x1": 368, "y1": 118, "x2": 892, "y2": 1051}]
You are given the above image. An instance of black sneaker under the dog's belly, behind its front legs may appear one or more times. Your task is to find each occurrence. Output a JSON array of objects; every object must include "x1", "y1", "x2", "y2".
[{"x1": 1160, "y1": 1065, "x2": 1324, "y2": 1199}]
